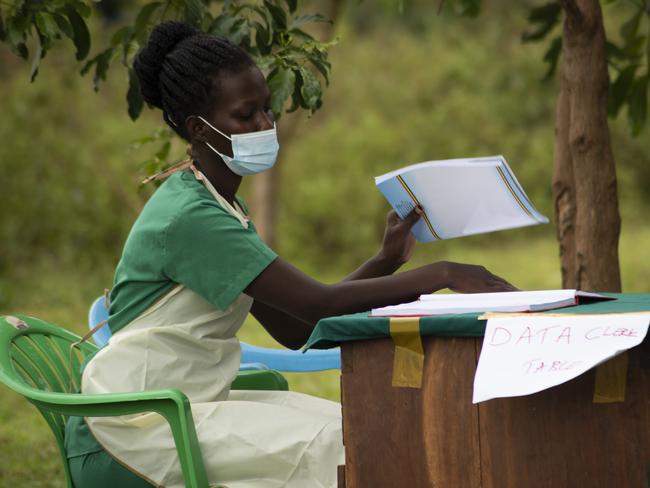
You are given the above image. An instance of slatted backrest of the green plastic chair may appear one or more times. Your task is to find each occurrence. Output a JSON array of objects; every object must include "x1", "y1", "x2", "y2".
[{"x1": 0, "y1": 316, "x2": 97, "y2": 487}]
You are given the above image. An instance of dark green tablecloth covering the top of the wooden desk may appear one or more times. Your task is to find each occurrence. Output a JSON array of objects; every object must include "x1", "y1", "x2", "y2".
[{"x1": 305, "y1": 293, "x2": 650, "y2": 349}]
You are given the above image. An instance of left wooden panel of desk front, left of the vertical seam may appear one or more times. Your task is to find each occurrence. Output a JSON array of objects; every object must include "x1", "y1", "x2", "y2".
[{"x1": 341, "y1": 339, "x2": 480, "y2": 488}]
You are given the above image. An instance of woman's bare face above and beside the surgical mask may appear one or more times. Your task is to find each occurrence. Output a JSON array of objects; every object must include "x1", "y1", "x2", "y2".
[{"x1": 192, "y1": 66, "x2": 274, "y2": 155}]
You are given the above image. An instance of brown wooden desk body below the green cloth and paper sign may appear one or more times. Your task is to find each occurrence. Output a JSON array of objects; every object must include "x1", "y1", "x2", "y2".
[{"x1": 339, "y1": 337, "x2": 650, "y2": 488}]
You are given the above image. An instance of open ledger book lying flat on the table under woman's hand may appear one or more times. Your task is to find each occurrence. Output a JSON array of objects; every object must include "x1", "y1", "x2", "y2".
[{"x1": 370, "y1": 290, "x2": 615, "y2": 317}]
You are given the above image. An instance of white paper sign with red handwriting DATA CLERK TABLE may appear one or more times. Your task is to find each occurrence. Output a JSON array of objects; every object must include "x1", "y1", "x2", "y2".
[{"x1": 473, "y1": 313, "x2": 650, "y2": 403}]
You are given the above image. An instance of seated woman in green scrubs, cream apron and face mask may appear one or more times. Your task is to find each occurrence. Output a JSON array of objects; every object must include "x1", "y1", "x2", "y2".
[{"x1": 66, "y1": 22, "x2": 512, "y2": 488}]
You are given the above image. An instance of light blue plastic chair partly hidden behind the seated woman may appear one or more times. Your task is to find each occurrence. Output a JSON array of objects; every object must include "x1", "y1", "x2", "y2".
[{"x1": 88, "y1": 296, "x2": 341, "y2": 373}]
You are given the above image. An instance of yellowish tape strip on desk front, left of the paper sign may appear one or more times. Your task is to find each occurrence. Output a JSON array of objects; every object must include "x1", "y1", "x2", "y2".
[{"x1": 390, "y1": 317, "x2": 424, "y2": 388}]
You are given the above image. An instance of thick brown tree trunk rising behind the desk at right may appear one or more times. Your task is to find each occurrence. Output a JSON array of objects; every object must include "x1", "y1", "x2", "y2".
[{"x1": 553, "y1": 0, "x2": 621, "y2": 292}]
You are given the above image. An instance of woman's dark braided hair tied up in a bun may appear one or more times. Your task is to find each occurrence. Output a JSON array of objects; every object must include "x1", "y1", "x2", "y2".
[{"x1": 133, "y1": 22, "x2": 255, "y2": 141}]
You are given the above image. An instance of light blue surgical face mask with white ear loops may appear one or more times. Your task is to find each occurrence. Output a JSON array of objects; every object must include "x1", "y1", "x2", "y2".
[{"x1": 199, "y1": 115, "x2": 280, "y2": 176}]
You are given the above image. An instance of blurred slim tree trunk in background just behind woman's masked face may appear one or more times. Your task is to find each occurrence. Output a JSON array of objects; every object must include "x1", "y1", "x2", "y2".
[{"x1": 252, "y1": 0, "x2": 343, "y2": 247}]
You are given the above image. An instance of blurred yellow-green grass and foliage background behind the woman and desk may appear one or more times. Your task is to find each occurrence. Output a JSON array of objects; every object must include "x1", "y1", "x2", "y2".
[{"x1": 0, "y1": 0, "x2": 650, "y2": 487}]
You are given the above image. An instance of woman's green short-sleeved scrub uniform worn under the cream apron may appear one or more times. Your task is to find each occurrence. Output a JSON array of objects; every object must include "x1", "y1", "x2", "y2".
[{"x1": 65, "y1": 171, "x2": 277, "y2": 488}]
